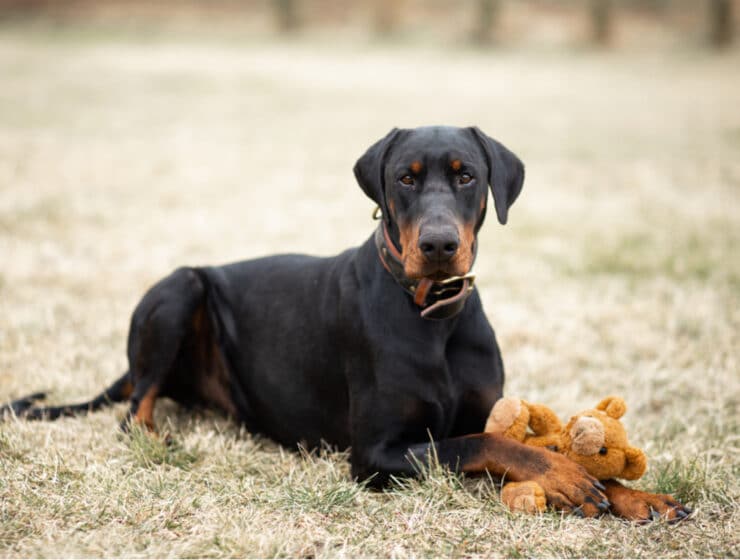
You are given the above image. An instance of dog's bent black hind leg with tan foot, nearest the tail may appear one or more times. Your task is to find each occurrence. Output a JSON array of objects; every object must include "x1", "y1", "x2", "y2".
[{"x1": 121, "y1": 268, "x2": 205, "y2": 431}]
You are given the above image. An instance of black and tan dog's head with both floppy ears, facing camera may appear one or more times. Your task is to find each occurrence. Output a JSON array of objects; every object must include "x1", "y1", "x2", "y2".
[{"x1": 354, "y1": 126, "x2": 524, "y2": 280}]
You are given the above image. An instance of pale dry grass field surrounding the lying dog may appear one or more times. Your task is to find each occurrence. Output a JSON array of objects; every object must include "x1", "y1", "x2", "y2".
[{"x1": 0, "y1": 20, "x2": 740, "y2": 557}]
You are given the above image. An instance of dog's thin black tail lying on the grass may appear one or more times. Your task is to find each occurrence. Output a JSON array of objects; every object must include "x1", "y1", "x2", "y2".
[{"x1": 0, "y1": 371, "x2": 133, "y2": 421}]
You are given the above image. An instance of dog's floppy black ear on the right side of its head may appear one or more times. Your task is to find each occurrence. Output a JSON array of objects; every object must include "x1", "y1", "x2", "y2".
[{"x1": 470, "y1": 126, "x2": 524, "y2": 224}]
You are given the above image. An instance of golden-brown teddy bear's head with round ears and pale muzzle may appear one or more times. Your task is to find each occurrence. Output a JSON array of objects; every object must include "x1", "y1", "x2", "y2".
[{"x1": 558, "y1": 397, "x2": 647, "y2": 480}]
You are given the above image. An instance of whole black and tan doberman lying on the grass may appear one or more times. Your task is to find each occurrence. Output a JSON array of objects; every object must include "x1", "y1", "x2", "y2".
[{"x1": 5, "y1": 127, "x2": 686, "y2": 519}]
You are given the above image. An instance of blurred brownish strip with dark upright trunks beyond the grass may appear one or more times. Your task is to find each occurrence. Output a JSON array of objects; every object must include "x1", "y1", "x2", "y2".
[{"x1": 0, "y1": 0, "x2": 738, "y2": 48}]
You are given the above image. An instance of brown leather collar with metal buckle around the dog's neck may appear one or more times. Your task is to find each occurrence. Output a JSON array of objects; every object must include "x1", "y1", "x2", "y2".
[{"x1": 375, "y1": 221, "x2": 475, "y2": 320}]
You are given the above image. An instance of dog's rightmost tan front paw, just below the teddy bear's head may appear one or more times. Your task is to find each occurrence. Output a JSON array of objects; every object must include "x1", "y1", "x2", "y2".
[{"x1": 603, "y1": 480, "x2": 691, "y2": 523}]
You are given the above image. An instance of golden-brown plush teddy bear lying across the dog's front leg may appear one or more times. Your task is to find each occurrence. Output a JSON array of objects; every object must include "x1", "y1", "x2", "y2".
[{"x1": 485, "y1": 397, "x2": 647, "y2": 513}]
